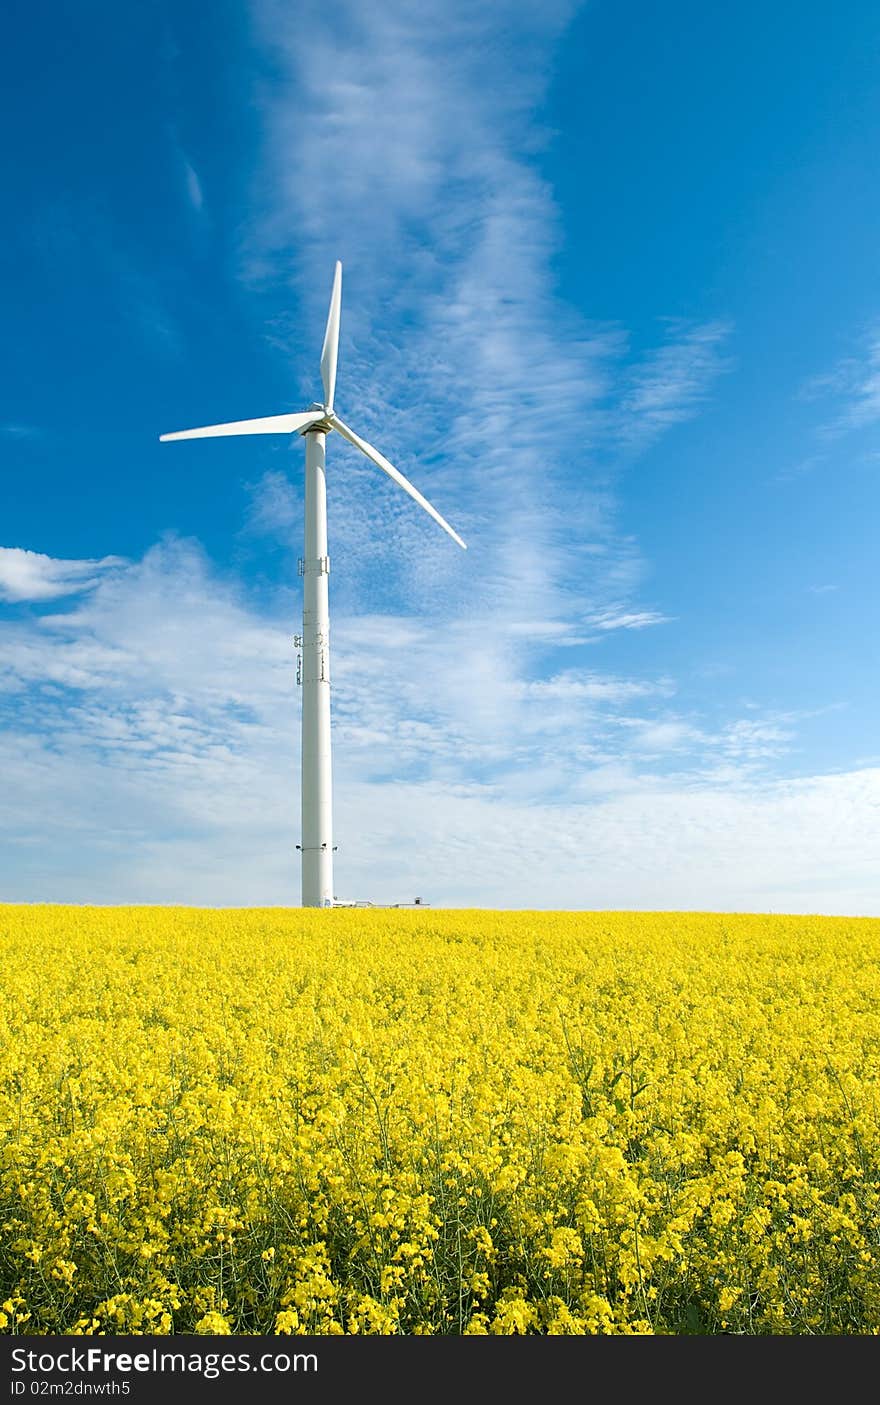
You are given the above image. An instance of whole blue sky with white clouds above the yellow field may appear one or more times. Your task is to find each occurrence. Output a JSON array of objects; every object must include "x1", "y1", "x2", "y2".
[{"x1": 0, "y1": 0, "x2": 880, "y2": 915}]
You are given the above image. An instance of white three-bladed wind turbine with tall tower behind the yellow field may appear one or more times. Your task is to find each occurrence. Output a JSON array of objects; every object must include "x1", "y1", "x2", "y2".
[{"x1": 159, "y1": 263, "x2": 467, "y2": 908}]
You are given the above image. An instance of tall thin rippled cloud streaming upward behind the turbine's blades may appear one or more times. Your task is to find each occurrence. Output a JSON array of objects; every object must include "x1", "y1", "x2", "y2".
[{"x1": 242, "y1": 0, "x2": 728, "y2": 651}]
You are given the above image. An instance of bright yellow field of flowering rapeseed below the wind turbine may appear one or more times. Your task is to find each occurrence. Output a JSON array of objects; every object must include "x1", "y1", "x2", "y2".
[{"x1": 0, "y1": 906, "x2": 880, "y2": 1335}]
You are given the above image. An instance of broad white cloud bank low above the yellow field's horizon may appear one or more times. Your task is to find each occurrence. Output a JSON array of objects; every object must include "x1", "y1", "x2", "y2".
[{"x1": 0, "y1": 540, "x2": 865, "y2": 912}]
